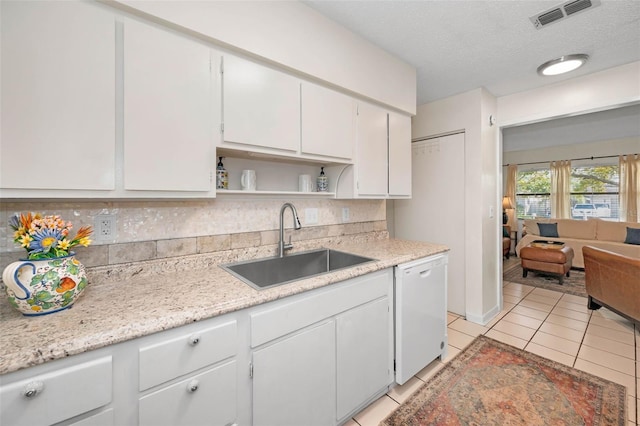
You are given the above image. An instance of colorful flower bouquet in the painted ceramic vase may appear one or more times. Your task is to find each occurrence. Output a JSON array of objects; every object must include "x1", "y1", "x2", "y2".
[{"x1": 9, "y1": 213, "x2": 93, "y2": 260}]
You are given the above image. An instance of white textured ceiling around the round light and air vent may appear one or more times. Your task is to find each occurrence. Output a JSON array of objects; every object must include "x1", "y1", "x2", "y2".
[{"x1": 304, "y1": 0, "x2": 640, "y2": 105}]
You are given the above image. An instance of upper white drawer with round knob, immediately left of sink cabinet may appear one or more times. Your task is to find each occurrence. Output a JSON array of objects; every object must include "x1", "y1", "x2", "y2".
[{"x1": 139, "y1": 320, "x2": 238, "y2": 391}]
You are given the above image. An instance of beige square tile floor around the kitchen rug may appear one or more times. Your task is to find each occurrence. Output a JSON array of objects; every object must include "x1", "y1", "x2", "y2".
[{"x1": 346, "y1": 258, "x2": 640, "y2": 426}]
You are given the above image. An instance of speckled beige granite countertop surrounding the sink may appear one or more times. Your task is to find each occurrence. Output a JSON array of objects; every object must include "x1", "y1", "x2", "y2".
[{"x1": 0, "y1": 239, "x2": 448, "y2": 374}]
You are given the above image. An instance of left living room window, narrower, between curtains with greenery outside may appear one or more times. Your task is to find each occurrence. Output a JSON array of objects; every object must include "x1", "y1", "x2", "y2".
[{"x1": 516, "y1": 168, "x2": 551, "y2": 219}]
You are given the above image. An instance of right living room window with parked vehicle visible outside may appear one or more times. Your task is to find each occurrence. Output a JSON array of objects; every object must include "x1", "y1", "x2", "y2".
[{"x1": 571, "y1": 164, "x2": 620, "y2": 221}]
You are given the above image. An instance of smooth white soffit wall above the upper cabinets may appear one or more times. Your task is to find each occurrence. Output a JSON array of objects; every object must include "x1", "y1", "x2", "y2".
[{"x1": 108, "y1": 0, "x2": 416, "y2": 114}]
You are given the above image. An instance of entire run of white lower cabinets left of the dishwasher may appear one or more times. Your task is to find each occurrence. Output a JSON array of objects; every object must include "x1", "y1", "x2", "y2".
[{"x1": 0, "y1": 268, "x2": 393, "y2": 426}]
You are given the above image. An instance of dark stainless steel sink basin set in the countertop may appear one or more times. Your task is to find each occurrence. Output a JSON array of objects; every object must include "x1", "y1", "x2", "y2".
[{"x1": 220, "y1": 249, "x2": 375, "y2": 290}]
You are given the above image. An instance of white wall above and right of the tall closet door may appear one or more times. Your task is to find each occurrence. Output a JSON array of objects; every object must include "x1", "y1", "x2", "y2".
[{"x1": 412, "y1": 89, "x2": 501, "y2": 323}]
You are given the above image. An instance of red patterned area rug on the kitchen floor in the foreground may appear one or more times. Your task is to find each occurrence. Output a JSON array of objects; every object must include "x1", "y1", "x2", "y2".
[{"x1": 380, "y1": 336, "x2": 626, "y2": 426}]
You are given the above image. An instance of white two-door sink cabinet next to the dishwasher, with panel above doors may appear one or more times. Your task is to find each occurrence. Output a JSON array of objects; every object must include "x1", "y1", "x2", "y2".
[{"x1": 250, "y1": 269, "x2": 393, "y2": 425}]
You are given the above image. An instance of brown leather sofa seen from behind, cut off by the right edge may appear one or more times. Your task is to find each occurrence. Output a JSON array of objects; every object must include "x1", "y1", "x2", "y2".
[{"x1": 582, "y1": 246, "x2": 640, "y2": 324}]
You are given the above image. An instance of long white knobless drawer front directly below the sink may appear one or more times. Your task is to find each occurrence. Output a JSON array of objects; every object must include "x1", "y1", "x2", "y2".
[{"x1": 251, "y1": 269, "x2": 393, "y2": 348}]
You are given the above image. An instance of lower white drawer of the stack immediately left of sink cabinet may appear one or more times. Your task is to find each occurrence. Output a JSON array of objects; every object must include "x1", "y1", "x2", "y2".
[{"x1": 139, "y1": 361, "x2": 237, "y2": 426}]
